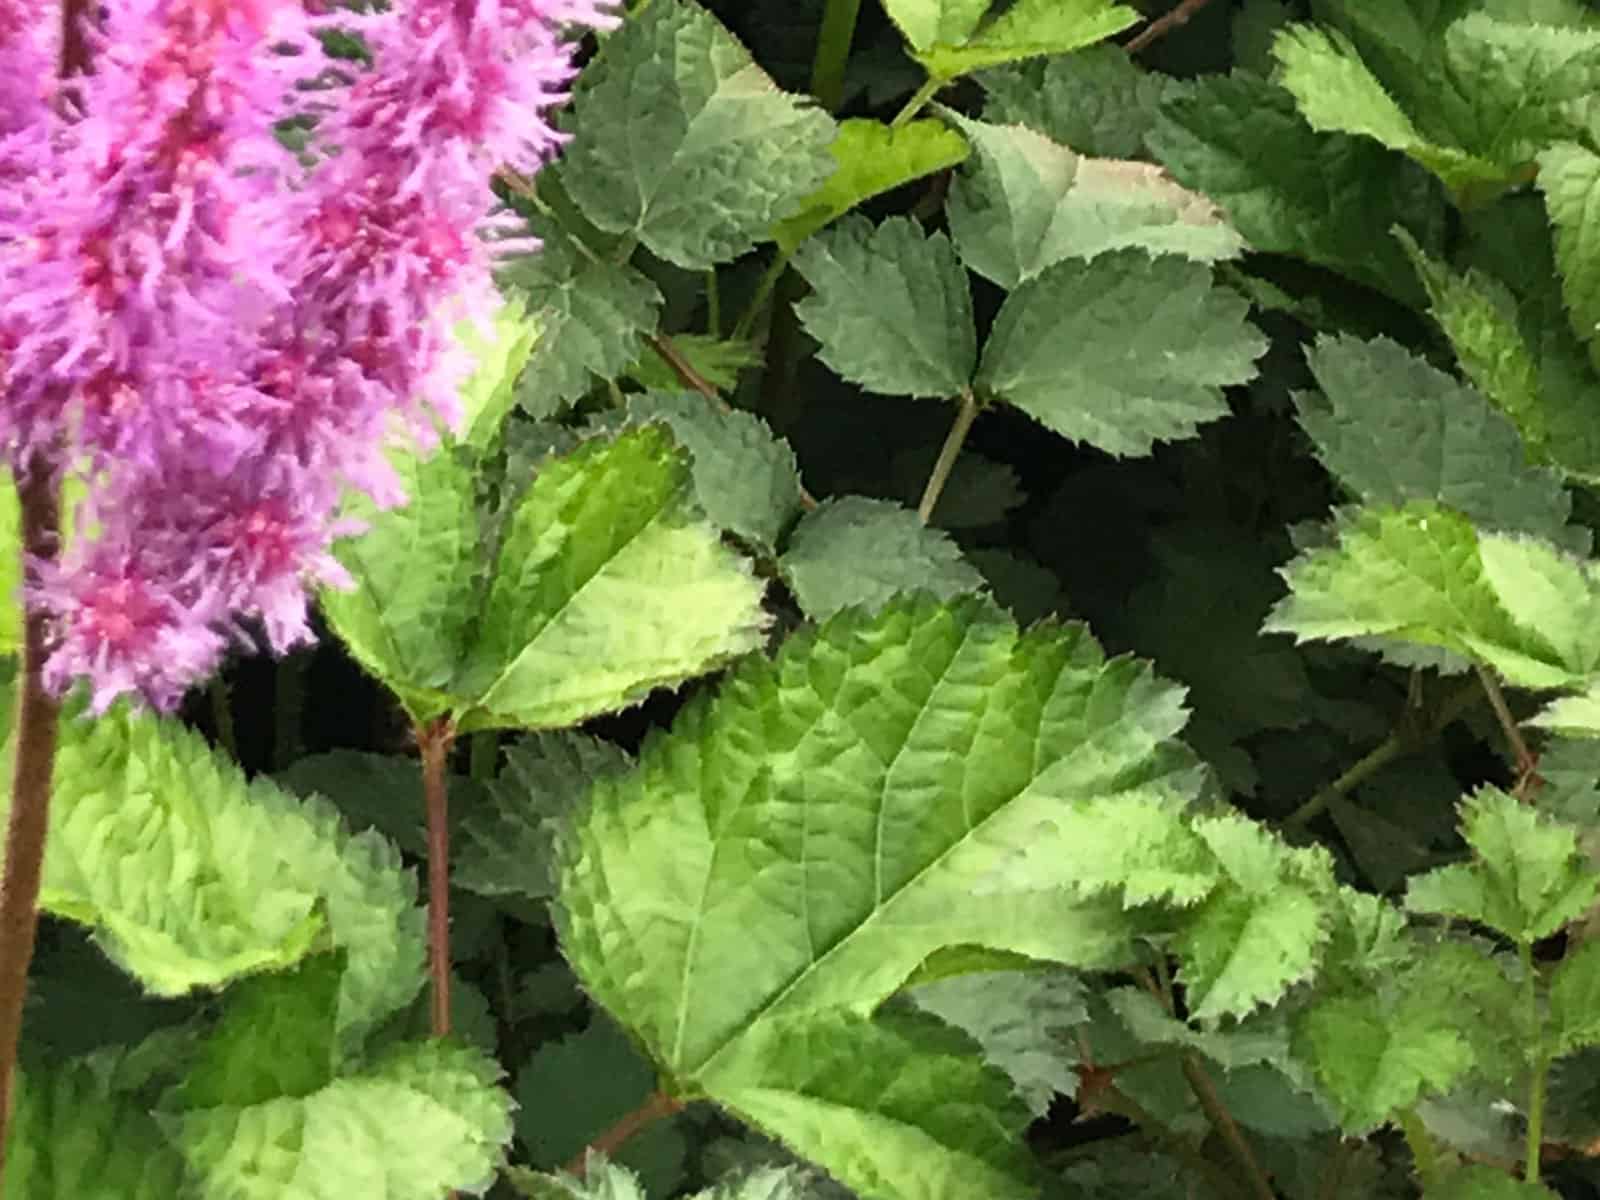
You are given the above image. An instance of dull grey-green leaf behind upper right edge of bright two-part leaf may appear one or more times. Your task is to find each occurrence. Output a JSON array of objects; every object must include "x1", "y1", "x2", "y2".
[{"x1": 627, "y1": 392, "x2": 800, "y2": 552}]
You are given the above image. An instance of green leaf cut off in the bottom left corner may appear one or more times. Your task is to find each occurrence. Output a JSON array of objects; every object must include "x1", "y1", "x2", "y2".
[{"x1": 5, "y1": 1062, "x2": 192, "y2": 1200}]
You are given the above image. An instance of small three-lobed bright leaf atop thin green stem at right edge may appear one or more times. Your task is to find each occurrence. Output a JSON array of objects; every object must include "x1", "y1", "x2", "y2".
[{"x1": 1405, "y1": 787, "x2": 1600, "y2": 946}]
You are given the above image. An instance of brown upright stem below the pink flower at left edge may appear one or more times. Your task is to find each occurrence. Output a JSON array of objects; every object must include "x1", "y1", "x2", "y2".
[{"x1": 0, "y1": 454, "x2": 61, "y2": 1194}]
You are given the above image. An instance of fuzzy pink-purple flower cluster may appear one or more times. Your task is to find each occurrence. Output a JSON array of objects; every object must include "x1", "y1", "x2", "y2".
[{"x1": 0, "y1": 0, "x2": 613, "y2": 709}]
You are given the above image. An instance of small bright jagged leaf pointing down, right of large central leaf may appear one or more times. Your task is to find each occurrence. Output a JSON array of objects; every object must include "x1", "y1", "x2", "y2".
[{"x1": 1178, "y1": 816, "x2": 1334, "y2": 1021}]
